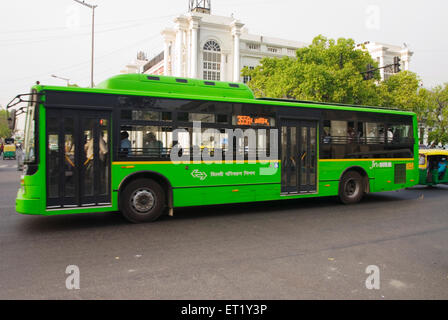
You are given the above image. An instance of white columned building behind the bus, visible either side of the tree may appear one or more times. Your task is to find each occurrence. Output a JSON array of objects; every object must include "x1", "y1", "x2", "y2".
[{"x1": 122, "y1": 0, "x2": 412, "y2": 82}]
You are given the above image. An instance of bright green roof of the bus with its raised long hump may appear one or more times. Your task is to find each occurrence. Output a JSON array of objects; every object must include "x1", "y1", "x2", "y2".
[{"x1": 35, "y1": 74, "x2": 415, "y2": 116}]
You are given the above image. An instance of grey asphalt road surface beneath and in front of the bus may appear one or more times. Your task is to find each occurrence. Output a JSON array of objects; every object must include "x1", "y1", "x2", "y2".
[{"x1": 0, "y1": 161, "x2": 448, "y2": 299}]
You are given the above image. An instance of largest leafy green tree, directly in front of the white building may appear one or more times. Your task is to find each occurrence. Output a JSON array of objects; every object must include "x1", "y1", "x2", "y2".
[{"x1": 242, "y1": 35, "x2": 380, "y2": 105}]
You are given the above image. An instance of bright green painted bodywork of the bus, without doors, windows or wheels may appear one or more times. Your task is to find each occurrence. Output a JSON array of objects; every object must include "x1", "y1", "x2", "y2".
[{"x1": 16, "y1": 74, "x2": 419, "y2": 215}]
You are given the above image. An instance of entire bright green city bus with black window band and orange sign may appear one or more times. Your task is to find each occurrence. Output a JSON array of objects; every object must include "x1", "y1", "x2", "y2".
[{"x1": 10, "y1": 74, "x2": 419, "y2": 223}]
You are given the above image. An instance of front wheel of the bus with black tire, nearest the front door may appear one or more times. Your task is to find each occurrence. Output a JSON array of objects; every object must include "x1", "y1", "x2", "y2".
[{"x1": 120, "y1": 179, "x2": 165, "y2": 223}]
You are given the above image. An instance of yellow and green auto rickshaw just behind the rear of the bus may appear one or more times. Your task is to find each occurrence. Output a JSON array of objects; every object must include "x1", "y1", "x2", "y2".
[{"x1": 419, "y1": 149, "x2": 448, "y2": 186}]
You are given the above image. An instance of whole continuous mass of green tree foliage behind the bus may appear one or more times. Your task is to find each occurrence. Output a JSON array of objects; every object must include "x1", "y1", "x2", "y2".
[{"x1": 242, "y1": 35, "x2": 448, "y2": 144}]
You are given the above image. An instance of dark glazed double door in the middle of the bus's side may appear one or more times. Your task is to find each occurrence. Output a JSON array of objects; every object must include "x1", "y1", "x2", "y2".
[{"x1": 280, "y1": 120, "x2": 317, "y2": 194}]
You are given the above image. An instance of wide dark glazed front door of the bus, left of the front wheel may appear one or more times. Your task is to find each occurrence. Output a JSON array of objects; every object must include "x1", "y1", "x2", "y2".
[{"x1": 46, "y1": 109, "x2": 111, "y2": 208}]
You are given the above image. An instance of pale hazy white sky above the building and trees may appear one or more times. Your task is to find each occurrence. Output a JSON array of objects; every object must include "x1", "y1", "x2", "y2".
[{"x1": 0, "y1": 0, "x2": 448, "y2": 107}]
